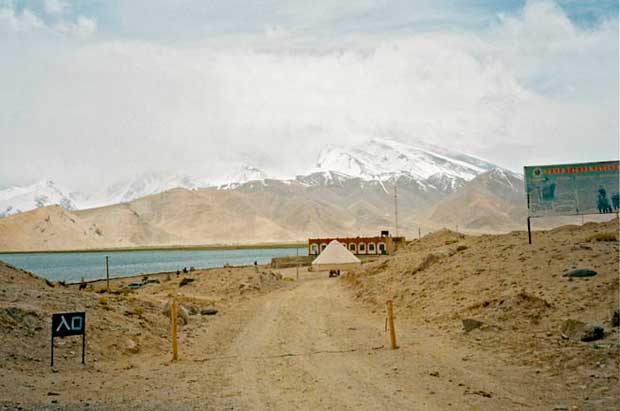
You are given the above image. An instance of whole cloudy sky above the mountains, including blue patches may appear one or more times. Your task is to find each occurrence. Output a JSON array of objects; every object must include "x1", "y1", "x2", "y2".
[{"x1": 0, "y1": 0, "x2": 619, "y2": 189}]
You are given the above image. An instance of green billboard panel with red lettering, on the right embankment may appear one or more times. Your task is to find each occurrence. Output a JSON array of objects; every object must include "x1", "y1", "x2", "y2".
[{"x1": 523, "y1": 161, "x2": 620, "y2": 217}]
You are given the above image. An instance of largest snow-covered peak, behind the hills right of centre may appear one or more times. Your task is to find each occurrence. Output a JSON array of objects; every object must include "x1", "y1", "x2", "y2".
[{"x1": 316, "y1": 139, "x2": 497, "y2": 183}]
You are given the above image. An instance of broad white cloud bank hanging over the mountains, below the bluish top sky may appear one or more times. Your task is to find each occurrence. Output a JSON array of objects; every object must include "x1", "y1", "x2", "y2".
[{"x1": 0, "y1": 2, "x2": 618, "y2": 190}]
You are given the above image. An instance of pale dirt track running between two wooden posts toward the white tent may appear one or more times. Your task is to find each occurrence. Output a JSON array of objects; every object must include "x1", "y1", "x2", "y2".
[{"x1": 211, "y1": 274, "x2": 537, "y2": 410}]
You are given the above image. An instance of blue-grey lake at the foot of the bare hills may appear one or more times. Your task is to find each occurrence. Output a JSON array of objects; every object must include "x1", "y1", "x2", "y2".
[{"x1": 0, "y1": 248, "x2": 308, "y2": 283}]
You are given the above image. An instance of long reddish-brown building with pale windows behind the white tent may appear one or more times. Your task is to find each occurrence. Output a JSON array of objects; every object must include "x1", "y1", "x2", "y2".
[{"x1": 308, "y1": 231, "x2": 405, "y2": 255}]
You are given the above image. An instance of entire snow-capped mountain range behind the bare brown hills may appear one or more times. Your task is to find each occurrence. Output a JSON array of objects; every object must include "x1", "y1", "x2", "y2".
[{"x1": 0, "y1": 139, "x2": 520, "y2": 217}]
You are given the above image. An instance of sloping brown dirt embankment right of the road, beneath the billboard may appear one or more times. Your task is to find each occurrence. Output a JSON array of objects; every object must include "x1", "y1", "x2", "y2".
[{"x1": 347, "y1": 219, "x2": 620, "y2": 409}]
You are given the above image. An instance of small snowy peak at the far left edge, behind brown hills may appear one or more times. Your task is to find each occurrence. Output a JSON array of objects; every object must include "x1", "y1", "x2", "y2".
[{"x1": 0, "y1": 180, "x2": 83, "y2": 217}]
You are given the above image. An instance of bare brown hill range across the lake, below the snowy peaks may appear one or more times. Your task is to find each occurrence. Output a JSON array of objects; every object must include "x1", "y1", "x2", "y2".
[{"x1": 0, "y1": 170, "x2": 525, "y2": 251}]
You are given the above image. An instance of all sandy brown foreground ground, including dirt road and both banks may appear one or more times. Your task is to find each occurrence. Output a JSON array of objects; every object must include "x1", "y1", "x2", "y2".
[{"x1": 0, "y1": 223, "x2": 620, "y2": 410}]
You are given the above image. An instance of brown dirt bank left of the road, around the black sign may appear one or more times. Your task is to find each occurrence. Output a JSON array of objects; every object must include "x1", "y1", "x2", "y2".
[{"x1": 0, "y1": 261, "x2": 291, "y2": 409}]
